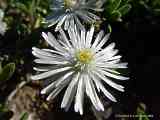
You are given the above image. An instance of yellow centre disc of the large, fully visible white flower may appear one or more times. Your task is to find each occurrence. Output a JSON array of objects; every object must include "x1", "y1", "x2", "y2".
[{"x1": 76, "y1": 49, "x2": 93, "y2": 64}]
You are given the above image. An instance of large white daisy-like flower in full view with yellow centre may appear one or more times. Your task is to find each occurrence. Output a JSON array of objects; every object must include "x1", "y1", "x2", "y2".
[{"x1": 31, "y1": 27, "x2": 128, "y2": 114}]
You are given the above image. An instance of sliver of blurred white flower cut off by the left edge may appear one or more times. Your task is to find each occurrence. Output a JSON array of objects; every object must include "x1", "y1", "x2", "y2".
[{"x1": 0, "y1": 9, "x2": 7, "y2": 35}]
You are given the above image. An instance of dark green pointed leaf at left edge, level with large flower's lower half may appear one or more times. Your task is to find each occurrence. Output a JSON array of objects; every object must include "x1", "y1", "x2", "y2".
[{"x1": 0, "y1": 63, "x2": 15, "y2": 82}]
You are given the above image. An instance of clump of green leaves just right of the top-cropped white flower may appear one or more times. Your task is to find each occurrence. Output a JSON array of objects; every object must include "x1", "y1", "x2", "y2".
[{"x1": 105, "y1": 0, "x2": 131, "y2": 22}]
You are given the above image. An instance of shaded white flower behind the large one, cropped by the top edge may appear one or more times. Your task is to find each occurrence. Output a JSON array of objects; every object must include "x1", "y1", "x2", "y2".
[{"x1": 45, "y1": 0, "x2": 105, "y2": 31}]
